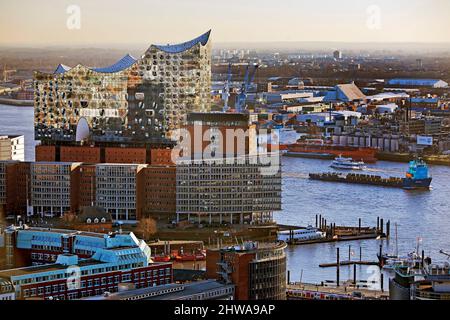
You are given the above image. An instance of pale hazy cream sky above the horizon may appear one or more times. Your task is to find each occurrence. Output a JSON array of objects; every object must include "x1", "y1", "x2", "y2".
[{"x1": 0, "y1": 0, "x2": 450, "y2": 45}]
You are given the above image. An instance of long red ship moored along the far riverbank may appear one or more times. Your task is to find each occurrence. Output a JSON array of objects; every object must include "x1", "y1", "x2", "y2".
[{"x1": 284, "y1": 139, "x2": 377, "y2": 163}]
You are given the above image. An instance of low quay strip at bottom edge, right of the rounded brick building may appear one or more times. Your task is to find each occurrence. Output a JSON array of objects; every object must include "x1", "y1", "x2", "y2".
[{"x1": 286, "y1": 282, "x2": 389, "y2": 300}]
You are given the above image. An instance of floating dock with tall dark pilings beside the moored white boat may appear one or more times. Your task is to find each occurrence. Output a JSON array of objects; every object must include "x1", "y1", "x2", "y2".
[{"x1": 278, "y1": 215, "x2": 391, "y2": 245}]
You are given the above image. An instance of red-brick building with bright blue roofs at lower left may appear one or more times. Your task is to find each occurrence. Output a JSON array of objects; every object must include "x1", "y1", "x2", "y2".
[{"x1": 0, "y1": 226, "x2": 172, "y2": 300}]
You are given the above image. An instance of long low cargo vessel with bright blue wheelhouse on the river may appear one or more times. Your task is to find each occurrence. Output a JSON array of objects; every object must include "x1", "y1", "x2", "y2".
[{"x1": 309, "y1": 159, "x2": 432, "y2": 190}]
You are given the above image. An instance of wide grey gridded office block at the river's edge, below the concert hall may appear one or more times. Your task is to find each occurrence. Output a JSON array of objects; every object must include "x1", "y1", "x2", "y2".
[{"x1": 176, "y1": 154, "x2": 281, "y2": 224}]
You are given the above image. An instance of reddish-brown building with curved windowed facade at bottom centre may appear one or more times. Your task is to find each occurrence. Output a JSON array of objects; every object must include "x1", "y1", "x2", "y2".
[{"x1": 206, "y1": 242, "x2": 286, "y2": 300}]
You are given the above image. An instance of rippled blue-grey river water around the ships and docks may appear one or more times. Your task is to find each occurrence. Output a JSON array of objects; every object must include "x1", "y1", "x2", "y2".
[{"x1": 0, "y1": 105, "x2": 450, "y2": 286}]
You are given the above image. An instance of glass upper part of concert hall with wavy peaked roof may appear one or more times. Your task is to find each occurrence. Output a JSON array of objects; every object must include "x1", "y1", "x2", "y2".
[{"x1": 34, "y1": 31, "x2": 211, "y2": 143}]
